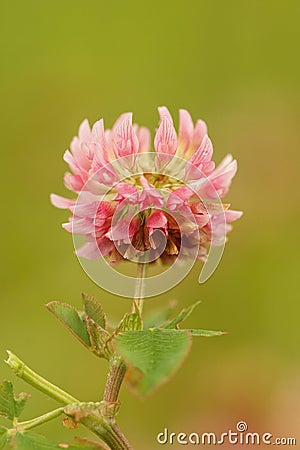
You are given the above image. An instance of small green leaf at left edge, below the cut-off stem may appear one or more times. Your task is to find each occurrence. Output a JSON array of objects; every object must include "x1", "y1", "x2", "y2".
[{"x1": 0, "y1": 381, "x2": 29, "y2": 420}]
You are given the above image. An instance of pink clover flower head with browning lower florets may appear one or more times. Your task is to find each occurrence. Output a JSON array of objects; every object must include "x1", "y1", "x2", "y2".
[{"x1": 51, "y1": 107, "x2": 242, "y2": 264}]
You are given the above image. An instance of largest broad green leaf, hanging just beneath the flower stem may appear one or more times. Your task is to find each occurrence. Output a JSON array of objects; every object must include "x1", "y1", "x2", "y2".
[{"x1": 114, "y1": 328, "x2": 191, "y2": 395}]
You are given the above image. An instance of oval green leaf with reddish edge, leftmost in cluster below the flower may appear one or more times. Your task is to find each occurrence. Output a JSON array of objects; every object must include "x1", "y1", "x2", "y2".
[{"x1": 46, "y1": 301, "x2": 91, "y2": 348}]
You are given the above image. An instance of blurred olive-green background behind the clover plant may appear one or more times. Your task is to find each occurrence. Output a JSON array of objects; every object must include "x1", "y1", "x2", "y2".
[{"x1": 0, "y1": 0, "x2": 300, "y2": 450}]
